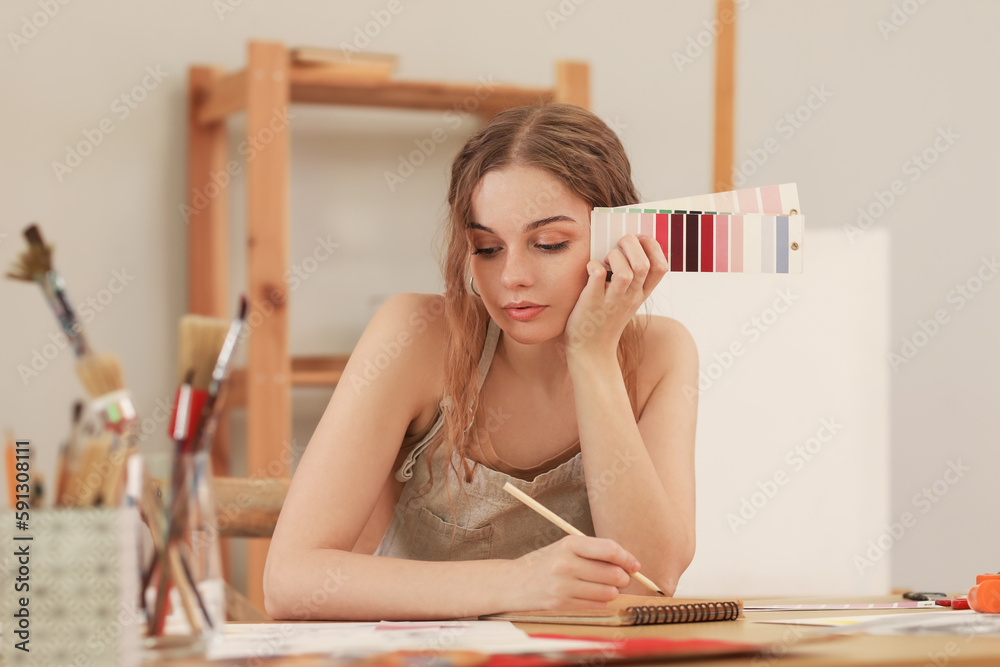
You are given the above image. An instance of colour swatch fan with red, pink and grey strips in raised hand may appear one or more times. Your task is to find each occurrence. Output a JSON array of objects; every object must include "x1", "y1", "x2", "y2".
[{"x1": 590, "y1": 183, "x2": 805, "y2": 273}]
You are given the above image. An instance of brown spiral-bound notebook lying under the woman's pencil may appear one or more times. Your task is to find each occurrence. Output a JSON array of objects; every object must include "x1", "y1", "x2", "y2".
[{"x1": 480, "y1": 594, "x2": 743, "y2": 626}]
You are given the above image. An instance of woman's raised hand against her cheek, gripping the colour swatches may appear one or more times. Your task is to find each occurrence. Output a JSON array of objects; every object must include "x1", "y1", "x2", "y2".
[{"x1": 563, "y1": 234, "x2": 667, "y2": 359}]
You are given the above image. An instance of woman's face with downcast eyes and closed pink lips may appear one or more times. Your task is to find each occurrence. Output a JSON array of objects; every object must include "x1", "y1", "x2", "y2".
[{"x1": 466, "y1": 166, "x2": 591, "y2": 344}]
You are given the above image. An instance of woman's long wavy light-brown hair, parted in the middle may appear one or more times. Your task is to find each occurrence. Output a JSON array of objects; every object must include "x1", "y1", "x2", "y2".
[{"x1": 427, "y1": 104, "x2": 648, "y2": 496}]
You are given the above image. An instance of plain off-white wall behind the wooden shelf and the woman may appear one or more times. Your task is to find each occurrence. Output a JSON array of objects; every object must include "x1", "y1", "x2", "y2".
[{"x1": 0, "y1": 0, "x2": 1000, "y2": 590}]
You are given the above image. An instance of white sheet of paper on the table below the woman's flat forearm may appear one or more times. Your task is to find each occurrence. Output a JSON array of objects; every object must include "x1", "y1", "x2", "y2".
[{"x1": 207, "y1": 621, "x2": 614, "y2": 660}]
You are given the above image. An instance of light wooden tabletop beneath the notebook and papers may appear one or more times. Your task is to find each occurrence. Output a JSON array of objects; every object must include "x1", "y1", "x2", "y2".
[{"x1": 144, "y1": 596, "x2": 1000, "y2": 667}]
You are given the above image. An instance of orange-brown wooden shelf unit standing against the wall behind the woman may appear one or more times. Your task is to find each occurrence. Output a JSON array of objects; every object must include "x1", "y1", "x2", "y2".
[{"x1": 187, "y1": 41, "x2": 590, "y2": 609}]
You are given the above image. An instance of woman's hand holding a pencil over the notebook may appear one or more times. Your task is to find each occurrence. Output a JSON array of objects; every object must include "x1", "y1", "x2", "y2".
[{"x1": 507, "y1": 535, "x2": 639, "y2": 611}]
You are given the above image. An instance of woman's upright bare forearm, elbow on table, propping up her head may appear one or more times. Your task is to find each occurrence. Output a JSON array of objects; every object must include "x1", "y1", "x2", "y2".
[{"x1": 570, "y1": 358, "x2": 694, "y2": 595}]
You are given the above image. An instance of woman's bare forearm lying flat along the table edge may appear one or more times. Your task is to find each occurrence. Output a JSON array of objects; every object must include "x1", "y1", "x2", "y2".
[{"x1": 264, "y1": 549, "x2": 517, "y2": 621}]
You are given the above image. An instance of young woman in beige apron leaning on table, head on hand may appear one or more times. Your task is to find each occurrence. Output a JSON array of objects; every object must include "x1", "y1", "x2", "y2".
[{"x1": 264, "y1": 104, "x2": 698, "y2": 620}]
